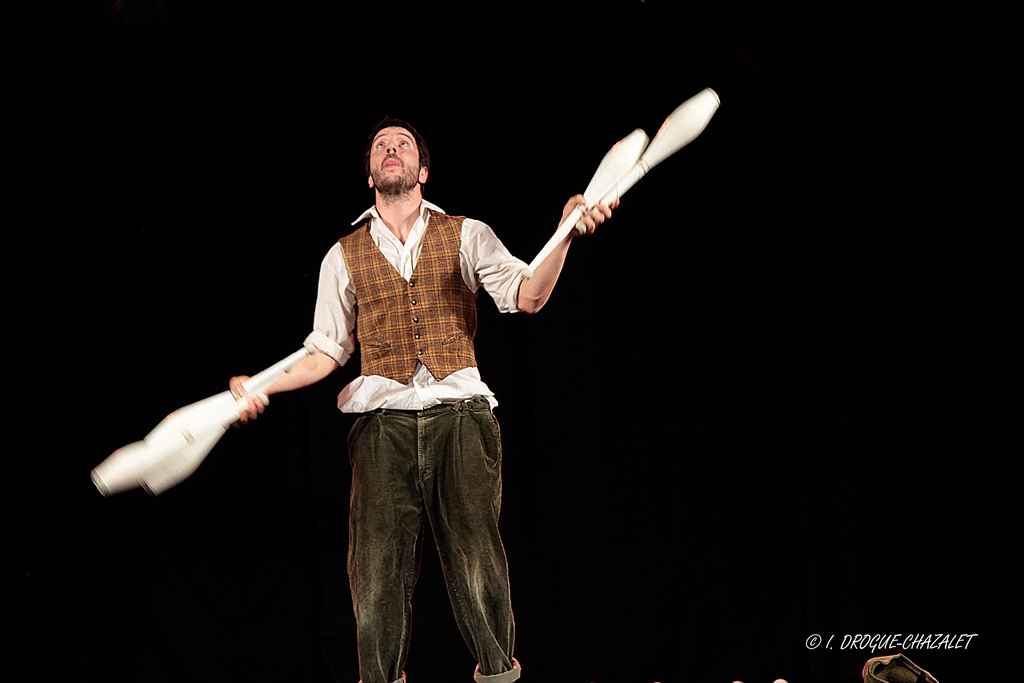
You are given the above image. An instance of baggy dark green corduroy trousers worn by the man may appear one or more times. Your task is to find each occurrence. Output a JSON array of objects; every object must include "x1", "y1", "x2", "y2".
[{"x1": 348, "y1": 399, "x2": 519, "y2": 683}]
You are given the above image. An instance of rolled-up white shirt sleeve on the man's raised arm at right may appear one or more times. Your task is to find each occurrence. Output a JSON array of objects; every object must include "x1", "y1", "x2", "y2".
[{"x1": 460, "y1": 218, "x2": 526, "y2": 313}]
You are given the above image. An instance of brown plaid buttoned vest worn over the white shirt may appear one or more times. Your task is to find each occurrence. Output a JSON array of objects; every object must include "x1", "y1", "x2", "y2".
[{"x1": 339, "y1": 211, "x2": 476, "y2": 384}]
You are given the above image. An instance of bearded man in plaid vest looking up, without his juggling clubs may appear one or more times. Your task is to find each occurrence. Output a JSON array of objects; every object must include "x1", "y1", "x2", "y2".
[{"x1": 230, "y1": 118, "x2": 617, "y2": 683}]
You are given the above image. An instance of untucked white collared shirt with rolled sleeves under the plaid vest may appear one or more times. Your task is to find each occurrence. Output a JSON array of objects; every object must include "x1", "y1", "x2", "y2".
[{"x1": 306, "y1": 201, "x2": 526, "y2": 413}]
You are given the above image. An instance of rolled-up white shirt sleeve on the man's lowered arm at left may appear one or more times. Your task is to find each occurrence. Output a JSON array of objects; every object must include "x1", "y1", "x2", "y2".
[{"x1": 306, "y1": 244, "x2": 355, "y2": 366}]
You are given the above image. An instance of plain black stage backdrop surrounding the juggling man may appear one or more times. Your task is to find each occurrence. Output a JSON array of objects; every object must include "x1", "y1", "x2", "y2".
[{"x1": 5, "y1": 0, "x2": 999, "y2": 683}]
